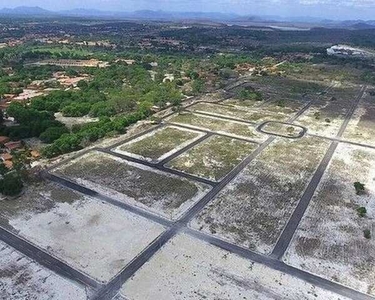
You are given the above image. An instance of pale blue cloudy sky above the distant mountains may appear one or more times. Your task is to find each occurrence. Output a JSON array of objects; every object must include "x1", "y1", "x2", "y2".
[{"x1": 0, "y1": 0, "x2": 375, "y2": 20}]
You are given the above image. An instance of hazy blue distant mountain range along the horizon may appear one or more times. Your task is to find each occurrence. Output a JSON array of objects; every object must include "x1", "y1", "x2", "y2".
[{"x1": 0, "y1": 6, "x2": 375, "y2": 29}]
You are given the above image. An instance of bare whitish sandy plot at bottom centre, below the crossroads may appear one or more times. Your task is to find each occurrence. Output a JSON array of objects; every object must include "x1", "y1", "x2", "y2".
[{"x1": 121, "y1": 234, "x2": 352, "y2": 300}]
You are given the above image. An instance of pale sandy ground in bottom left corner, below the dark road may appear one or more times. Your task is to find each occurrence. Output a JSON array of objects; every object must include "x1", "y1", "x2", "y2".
[{"x1": 0, "y1": 241, "x2": 88, "y2": 300}]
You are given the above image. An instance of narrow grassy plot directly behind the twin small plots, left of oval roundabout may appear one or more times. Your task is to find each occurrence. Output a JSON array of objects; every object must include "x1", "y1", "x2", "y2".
[{"x1": 168, "y1": 112, "x2": 267, "y2": 142}]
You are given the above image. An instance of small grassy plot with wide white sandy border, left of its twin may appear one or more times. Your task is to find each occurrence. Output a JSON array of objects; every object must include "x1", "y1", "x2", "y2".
[{"x1": 114, "y1": 126, "x2": 204, "y2": 162}]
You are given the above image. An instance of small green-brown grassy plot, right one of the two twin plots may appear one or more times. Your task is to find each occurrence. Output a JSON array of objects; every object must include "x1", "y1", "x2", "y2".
[{"x1": 167, "y1": 136, "x2": 257, "y2": 181}]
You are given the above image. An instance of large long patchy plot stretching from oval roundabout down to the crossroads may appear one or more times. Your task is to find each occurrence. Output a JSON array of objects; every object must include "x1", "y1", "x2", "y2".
[{"x1": 191, "y1": 137, "x2": 329, "y2": 254}]
